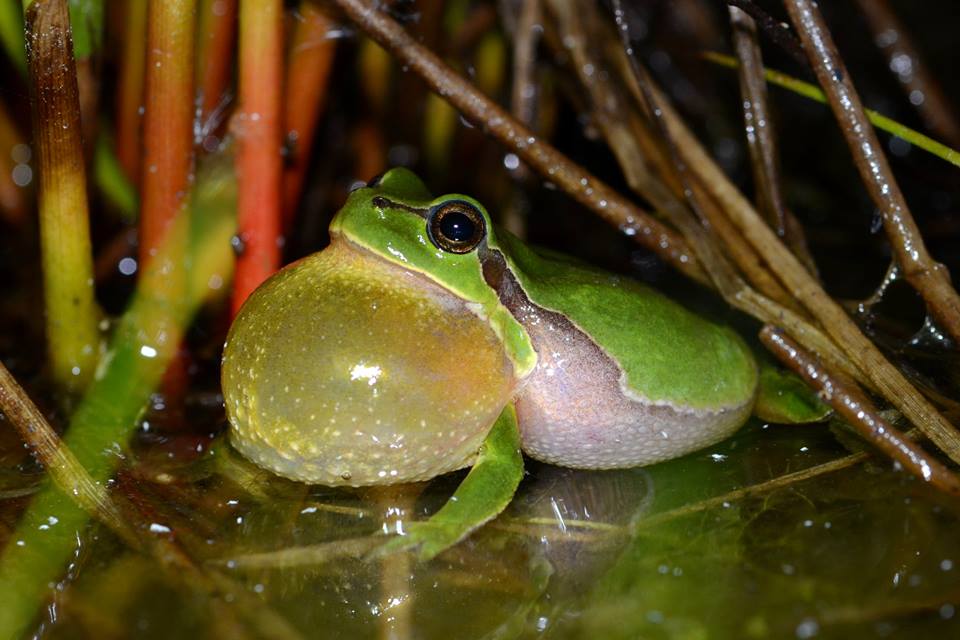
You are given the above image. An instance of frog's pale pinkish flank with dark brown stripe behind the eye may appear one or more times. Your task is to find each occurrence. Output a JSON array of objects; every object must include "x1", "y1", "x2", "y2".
[{"x1": 480, "y1": 245, "x2": 750, "y2": 469}]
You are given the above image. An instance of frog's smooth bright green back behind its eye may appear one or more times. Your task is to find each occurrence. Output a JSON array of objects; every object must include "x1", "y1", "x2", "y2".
[{"x1": 496, "y1": 229, "x2": 757, "y2": 410}]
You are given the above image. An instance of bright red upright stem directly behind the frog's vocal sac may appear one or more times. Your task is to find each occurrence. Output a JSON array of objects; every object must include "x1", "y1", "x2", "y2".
[{"x1": 230, "y1": 0, "x2": 283, "y2": 315}]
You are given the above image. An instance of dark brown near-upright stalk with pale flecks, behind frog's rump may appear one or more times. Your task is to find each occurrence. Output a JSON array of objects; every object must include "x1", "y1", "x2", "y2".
[{"x1": 729, "y1": 6, "x2": 817, "y2": 274}]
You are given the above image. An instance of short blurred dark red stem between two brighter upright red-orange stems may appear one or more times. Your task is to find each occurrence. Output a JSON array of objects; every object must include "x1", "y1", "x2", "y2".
[{"x1": 197, "y1": 0, "x2": 237, "y2": 134}]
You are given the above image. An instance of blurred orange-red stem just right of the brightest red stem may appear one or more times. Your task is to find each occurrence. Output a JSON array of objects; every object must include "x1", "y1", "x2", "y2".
[{"x1": 283, "y1": 0, "x2": 336, "y2": 225}]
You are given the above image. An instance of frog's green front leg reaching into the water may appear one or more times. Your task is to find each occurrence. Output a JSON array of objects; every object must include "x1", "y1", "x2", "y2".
[{"x1": 378, "y1": 404, "x2": 523, "y2": 560}]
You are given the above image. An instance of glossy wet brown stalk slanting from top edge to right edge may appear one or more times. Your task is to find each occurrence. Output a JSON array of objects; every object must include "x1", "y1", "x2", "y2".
[{"x1": 784, "y1": 0, "x2": 960, "y2": 342}]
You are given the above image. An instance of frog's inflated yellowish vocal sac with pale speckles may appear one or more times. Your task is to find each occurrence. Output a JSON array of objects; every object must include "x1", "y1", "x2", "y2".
[{"x1": 222, "y1": 239, "x2": 516, "y2": 486}]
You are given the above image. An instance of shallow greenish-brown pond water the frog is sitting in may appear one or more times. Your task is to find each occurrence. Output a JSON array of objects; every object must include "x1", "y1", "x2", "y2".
[{"x1": 4, "y1": 404, "x2": 960, "y2": 638}]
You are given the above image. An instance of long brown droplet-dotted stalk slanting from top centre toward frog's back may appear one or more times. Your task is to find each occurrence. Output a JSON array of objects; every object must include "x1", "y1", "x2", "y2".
[{"x1": 334, "y1": 0, "x2": 707, "y2": 283}]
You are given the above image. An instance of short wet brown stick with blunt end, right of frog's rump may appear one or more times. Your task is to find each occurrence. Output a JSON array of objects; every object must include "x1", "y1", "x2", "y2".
[{"x1": 760, "y1": 325, "x2": 960, "y2": 495}]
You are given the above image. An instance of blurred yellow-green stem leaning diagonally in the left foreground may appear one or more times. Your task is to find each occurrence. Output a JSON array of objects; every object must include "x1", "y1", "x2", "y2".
[{"x1": 0, "y1": 160, "x2": 235, "y2": 638}]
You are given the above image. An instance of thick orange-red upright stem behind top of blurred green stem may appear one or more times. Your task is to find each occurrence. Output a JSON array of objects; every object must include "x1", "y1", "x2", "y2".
[{"x1": 140, "y1": 0, "x2": 196, "y2": 266}]
